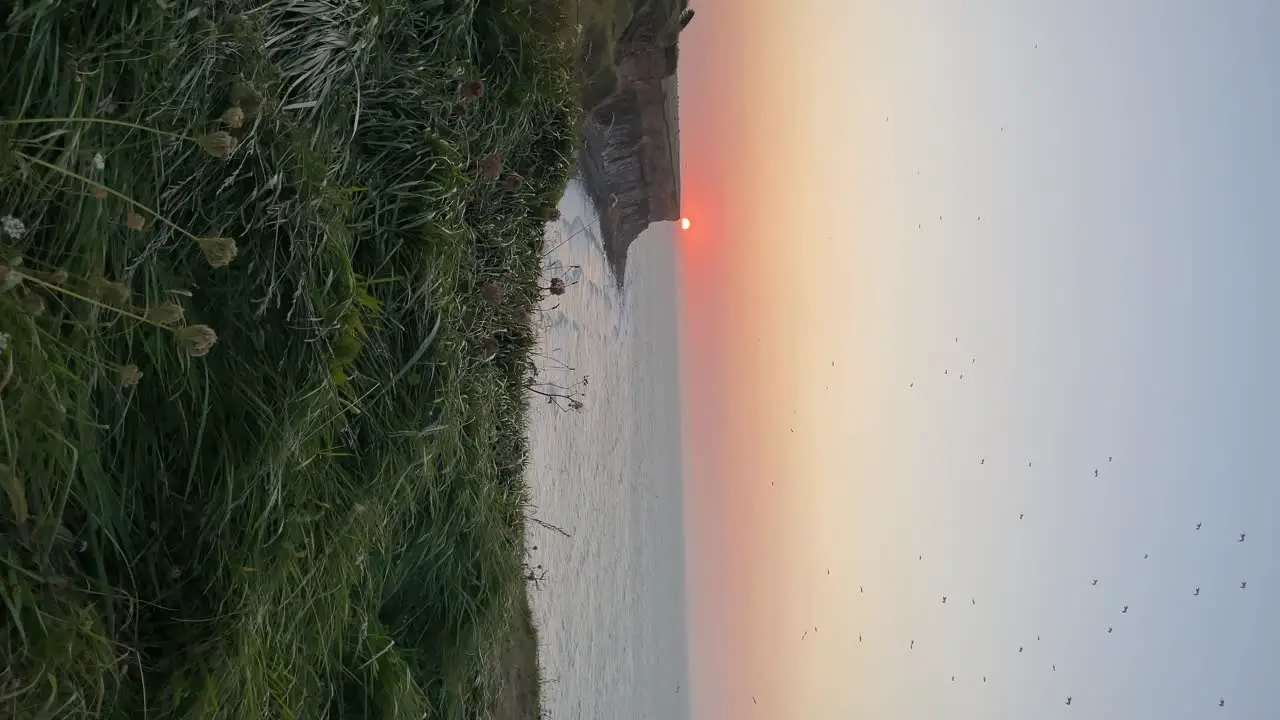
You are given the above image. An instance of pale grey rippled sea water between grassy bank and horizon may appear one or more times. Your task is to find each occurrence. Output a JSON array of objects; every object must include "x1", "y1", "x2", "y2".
[{"x1": 530, "y1": 184, "x2": 689, "y2": 720}]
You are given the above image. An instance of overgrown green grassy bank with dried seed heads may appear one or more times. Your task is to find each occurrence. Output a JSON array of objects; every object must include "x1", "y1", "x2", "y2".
[{"x1": 0, "y1": 0, "x2": 579, "y2": 720}]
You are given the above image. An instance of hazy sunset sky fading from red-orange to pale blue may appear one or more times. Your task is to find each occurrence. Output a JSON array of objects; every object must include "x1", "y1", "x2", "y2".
[{"x1": 677, "y1": 0, "x2": 1280, "y2": 720}]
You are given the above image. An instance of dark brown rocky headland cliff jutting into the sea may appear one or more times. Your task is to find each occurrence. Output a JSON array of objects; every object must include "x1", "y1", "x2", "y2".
[{"x1": 579, "y1": 0, "x2": 692, "y2": 284}]
